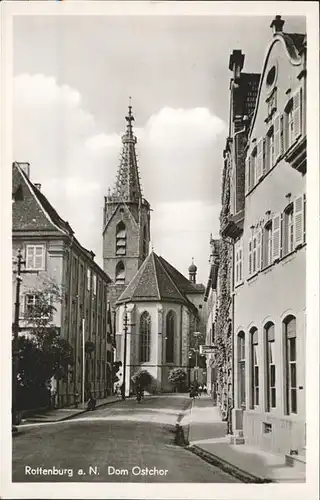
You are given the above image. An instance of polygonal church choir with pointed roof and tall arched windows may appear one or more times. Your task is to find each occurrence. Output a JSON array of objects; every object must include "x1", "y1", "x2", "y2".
[{"x1": 116, "y1": 252, "x2": 204, "y2": 395}]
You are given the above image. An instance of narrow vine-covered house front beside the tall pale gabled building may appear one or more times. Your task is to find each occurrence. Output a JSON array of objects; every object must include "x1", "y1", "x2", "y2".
[{"x1": 214, "y1": 50, "x2": 260, "y2": 426}]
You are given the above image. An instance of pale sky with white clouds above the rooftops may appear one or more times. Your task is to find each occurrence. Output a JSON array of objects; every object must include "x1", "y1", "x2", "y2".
[{"x1": 13, "y1": 15, "x2": 305, "y2": 283}]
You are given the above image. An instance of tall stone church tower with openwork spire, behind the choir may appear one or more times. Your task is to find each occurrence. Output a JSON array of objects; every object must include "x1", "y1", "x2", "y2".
[{"x1": 103, "y1": 105, "x2": 150, "y2": 303}]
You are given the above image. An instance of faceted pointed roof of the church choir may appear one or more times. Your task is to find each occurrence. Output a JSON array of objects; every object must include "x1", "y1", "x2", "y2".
[{"x1": 116, "y1": 252, "x2": 204, "y2": 309}]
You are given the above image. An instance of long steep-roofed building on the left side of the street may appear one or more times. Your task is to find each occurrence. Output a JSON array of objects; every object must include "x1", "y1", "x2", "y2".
[{"x1": 12, "y1": 163, "x2": 114, "y2": 406}]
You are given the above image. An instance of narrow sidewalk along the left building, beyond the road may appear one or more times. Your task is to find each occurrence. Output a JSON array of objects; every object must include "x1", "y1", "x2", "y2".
[{"x1": 20, "y1": 396, "x2": 122, "y2": 426}]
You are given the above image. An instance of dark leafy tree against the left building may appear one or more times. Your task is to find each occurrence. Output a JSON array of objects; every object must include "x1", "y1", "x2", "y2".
[{"x1": 18, "y1": 279, "x2": 73, "y2": 406}]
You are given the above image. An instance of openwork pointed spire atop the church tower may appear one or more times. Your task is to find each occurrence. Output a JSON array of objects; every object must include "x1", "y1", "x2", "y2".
[{"x1": 113, "y1": 97, "x2": 142, "y2": 202}]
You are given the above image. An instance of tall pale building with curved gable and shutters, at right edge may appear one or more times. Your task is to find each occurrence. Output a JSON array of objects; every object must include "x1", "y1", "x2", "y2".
[{"x1": 233, "y1": 16, "x2": 306, "y2": 455}]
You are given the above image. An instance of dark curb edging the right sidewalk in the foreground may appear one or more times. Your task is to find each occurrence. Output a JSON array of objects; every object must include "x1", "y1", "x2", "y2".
[{"x1": 185, "y1": 445, "x2": 274, "y2": 484}]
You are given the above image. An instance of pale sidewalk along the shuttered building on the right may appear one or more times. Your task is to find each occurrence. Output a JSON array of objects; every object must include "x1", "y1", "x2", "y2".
[{"x1": 181, "y1": 395, "x2": 305, "y2": 483}]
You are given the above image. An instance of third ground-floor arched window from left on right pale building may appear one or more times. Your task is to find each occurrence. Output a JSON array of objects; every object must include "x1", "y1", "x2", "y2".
[{"x1": 264, "y1": 323, "x2": 276, "y2": 411}]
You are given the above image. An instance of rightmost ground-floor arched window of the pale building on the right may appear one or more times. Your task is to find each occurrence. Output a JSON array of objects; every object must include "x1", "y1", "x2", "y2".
[{"x1": 283, "y1": 315, "x2": 297, "y2": 415}]
